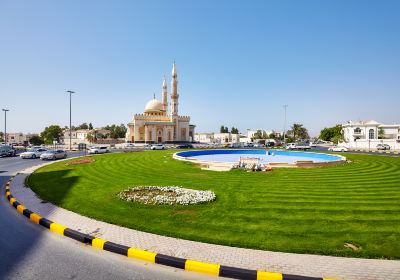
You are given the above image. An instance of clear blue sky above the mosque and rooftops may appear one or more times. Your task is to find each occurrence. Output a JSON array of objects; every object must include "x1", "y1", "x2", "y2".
[{"x1": 0, "y1": 0, "x2": 400, "y2": 135}]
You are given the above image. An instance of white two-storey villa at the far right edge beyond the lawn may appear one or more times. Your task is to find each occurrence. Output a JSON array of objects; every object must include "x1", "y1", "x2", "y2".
[{"x1": 339, "y1": 120, "x2": 400, "y2": 150}]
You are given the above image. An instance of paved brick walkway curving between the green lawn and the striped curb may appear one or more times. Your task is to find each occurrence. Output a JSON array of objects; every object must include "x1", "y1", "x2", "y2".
[{"x1": 11, "y1": 167, "x2": 400, "y2": 280}]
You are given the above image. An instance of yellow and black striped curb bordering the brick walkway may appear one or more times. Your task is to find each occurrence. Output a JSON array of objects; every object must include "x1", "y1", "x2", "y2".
[{"x1": 5, "y1": 177, "x2": 333, "y2": 280}]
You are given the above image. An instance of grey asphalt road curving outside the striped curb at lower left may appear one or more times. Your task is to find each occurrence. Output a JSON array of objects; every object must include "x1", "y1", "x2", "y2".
[{"x1": 0, "y1": 153, "x2": 215, "y2": 279}]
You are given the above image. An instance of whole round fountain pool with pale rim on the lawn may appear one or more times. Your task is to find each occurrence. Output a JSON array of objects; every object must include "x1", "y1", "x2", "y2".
[{"x1": 174, "y1": 149, "x2": 346, "y2": 170}]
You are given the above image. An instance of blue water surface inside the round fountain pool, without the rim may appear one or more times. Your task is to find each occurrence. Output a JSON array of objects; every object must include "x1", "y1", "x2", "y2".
[{"x1": 177, "y1": 150, "x2": 341, "y2": 164}]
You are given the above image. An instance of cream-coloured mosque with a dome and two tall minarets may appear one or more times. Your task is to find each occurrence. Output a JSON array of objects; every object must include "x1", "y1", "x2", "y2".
[{"x1": 125, "y1": 62, "x2": 195, "y2": 143}]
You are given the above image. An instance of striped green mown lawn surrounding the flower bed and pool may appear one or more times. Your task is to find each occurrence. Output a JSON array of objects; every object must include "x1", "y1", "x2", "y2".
[{"x1": 28, "y1": 151, "x2": 400, "y2": 259}]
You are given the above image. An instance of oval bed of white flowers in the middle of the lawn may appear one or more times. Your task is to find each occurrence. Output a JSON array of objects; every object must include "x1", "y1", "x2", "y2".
[{"x1": 118, "y1": 186, "x2": 216, "y2": 205}]
